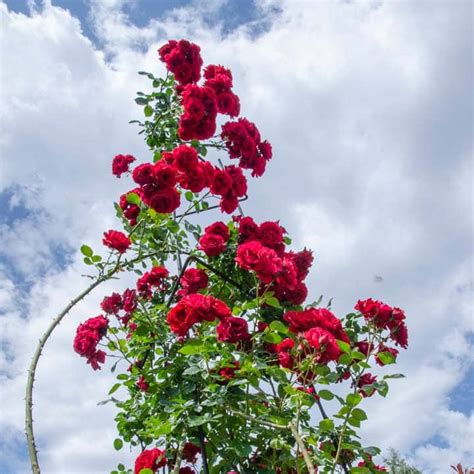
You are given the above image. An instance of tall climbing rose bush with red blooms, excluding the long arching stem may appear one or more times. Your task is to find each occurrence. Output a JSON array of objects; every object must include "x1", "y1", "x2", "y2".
[{"x1": 73, "y1": 40, "x2": 407, "y2": 474}]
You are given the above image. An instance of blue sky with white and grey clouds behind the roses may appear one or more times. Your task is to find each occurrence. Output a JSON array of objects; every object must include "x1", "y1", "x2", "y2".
[{"x1": 0, "y1": 0, "x2": 474, "y2": 474}]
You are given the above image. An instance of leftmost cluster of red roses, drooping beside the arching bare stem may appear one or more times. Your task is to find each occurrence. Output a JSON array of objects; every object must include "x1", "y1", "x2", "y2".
[{"x1": 73, "y1": 315, "x2": 109, "y2": 370}]
